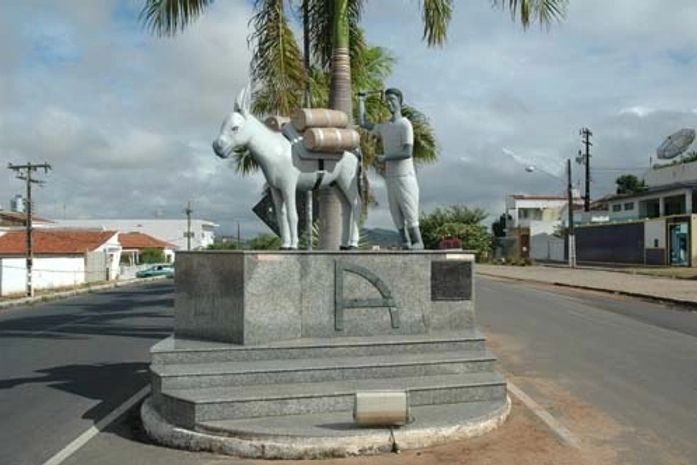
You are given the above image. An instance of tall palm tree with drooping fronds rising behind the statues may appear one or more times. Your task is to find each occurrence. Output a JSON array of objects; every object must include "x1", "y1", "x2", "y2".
[{"x1": 141, "y1": 0, "x2": 568, "y2": 249}]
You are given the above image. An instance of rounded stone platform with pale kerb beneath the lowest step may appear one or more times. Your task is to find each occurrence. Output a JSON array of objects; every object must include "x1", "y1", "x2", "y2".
[{"x1": 141, "y1": 396, "x2": 511, "y2": 459}]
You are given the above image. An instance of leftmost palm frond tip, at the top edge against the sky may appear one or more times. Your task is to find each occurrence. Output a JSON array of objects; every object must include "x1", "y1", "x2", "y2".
[{"x1": 138, "y1": 0, "x2": 213, "y2": 37}]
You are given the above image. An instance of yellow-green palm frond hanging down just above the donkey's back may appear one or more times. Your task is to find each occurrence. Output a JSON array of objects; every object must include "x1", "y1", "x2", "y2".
[{"x1": 248, "y1": 0, "x2": 306, "y2": 115}]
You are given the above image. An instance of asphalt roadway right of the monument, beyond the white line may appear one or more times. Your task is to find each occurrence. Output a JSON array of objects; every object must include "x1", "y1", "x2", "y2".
[{"x1": 477, "y1": 279, "x2": 697, "y2": 465}]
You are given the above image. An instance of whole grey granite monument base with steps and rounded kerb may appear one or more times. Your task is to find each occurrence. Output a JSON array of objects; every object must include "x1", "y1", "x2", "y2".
[{"x1": 143, "y1": 251, "x2": 510, "y2": 458}]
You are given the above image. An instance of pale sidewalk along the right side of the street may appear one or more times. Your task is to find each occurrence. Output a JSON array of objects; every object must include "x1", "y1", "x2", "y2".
[{"x1": 476, "y1": 264, "x2": 697, "y2": 307}]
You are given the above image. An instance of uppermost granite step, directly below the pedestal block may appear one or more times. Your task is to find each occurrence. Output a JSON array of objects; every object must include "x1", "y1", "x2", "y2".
[{"x1": 150, "y1": 330, "x2": 485, "y2": 365}]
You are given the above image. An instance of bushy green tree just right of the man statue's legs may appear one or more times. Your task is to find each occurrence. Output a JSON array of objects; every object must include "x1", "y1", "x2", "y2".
[{"x1": 419, "y1": 205, "x2": 493, "y2": 257}]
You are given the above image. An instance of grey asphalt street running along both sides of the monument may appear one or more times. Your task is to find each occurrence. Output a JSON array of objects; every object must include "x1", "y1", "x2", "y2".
[{"x1": 0, "y1": 278, "x2": 697, "y2": 465}]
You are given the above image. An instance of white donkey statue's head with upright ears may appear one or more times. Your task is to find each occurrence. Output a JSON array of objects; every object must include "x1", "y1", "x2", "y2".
[{"x1": 213, "y1": 86, "x2": 254, "y2": 158}]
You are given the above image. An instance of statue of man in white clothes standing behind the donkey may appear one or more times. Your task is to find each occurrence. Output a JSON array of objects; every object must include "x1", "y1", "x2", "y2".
[{"x1": 358, "y1": 88, "x2": 424, "y2": 249}]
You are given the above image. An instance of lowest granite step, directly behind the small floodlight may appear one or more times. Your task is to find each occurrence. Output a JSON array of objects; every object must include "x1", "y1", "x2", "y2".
[{"x1": 153, "y1": 372, "x2": 506, "y2": 428}]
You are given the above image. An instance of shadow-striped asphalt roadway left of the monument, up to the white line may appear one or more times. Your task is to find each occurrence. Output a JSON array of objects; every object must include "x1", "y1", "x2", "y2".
[{"x1": 0, "y1": 282, "x2": 172, "y2": 465}]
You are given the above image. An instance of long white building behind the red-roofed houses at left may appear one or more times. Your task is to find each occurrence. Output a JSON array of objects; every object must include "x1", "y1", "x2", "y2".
[{"x1": 48, "y1": 218, "x2": 218, "y2": 250}]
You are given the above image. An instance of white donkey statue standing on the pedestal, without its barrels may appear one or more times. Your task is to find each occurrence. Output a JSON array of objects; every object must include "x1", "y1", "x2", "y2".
[{"x1": 213, "y1": 86, "x2": 361, "y2": 249}]
